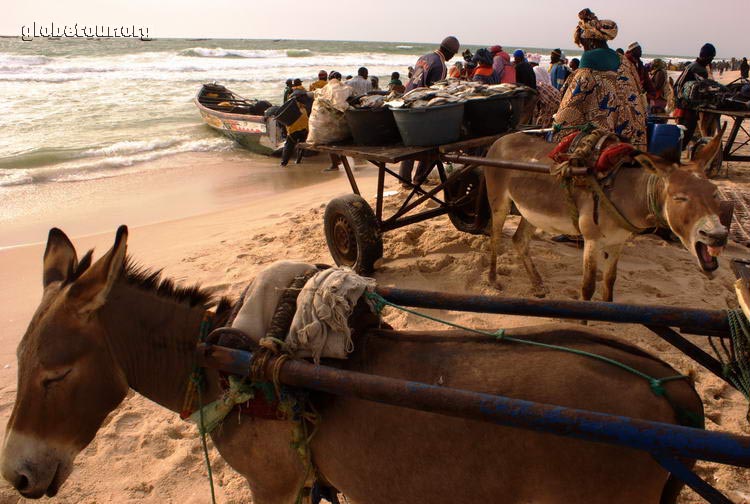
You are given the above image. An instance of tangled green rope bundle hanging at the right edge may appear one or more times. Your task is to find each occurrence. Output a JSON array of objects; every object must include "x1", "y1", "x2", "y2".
[{"x1": 709, "y1": 310, "x2": 750, "y2": 400}]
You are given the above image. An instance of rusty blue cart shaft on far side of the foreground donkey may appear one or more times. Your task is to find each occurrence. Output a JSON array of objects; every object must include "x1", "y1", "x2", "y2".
[{"x1": 376, "y1": 287, "x2": 729, "y2": 337}]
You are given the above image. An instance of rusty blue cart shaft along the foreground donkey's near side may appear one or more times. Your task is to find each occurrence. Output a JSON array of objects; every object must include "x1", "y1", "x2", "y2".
[{"x1": 198, "y1": 345, "x2": 750, "y2": 467}]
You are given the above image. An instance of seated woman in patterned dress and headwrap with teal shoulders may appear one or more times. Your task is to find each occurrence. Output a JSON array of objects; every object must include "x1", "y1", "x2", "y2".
[{"x1": 554, "y1": 9, "x2": 646, "y2": 149}]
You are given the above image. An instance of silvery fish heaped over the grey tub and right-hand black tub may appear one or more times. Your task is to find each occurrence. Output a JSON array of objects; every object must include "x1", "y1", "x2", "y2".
[{"x1": 385, "y1": 79, "x2": 527, "y2": 108}]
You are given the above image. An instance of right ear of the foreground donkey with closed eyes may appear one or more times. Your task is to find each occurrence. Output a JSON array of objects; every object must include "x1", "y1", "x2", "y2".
[{"x1": 68, "y1": 226, "x2": 128, "y2": 315}]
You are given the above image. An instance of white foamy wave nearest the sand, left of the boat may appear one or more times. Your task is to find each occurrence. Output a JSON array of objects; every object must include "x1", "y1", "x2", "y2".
[{"x1": 0, "y1": 137, "x2": 234, "y2": 187}]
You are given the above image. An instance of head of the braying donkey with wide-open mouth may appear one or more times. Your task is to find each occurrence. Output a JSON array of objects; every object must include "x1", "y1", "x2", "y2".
[{"x1": 639, "y1": 132, "x2": 729, "y2": 272}]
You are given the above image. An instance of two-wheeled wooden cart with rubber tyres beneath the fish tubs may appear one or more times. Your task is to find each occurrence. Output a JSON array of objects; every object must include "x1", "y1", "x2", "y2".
[{"x1": 301, "y1": 135, "x2": 568, "y2": 274}]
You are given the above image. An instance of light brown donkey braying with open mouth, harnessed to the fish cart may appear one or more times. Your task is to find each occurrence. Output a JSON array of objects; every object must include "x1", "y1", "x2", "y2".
[{"x1": 484, "y1": 133, "x2": 728, "y2": 301}]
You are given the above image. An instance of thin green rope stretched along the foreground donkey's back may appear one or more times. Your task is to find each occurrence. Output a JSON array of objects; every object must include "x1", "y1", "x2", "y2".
[{"x1": 366, "y1": 292, "x2": 688, "y2": 396}]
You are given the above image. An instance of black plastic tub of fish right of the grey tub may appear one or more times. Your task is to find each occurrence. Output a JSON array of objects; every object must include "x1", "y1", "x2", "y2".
[{"x1": 464, "y1": 95, "x2": 524, "y2": 136}]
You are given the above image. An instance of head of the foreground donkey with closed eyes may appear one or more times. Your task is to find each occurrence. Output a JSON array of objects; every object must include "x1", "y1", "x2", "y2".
[{"x1": 2, "y1": 226, "x2": 128, "y2": 498}]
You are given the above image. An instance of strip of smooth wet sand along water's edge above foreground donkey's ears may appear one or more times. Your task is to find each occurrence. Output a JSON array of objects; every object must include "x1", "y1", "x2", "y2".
[{"x1": 0, "y1": 152, "x2": 370, "y2": 251}]
